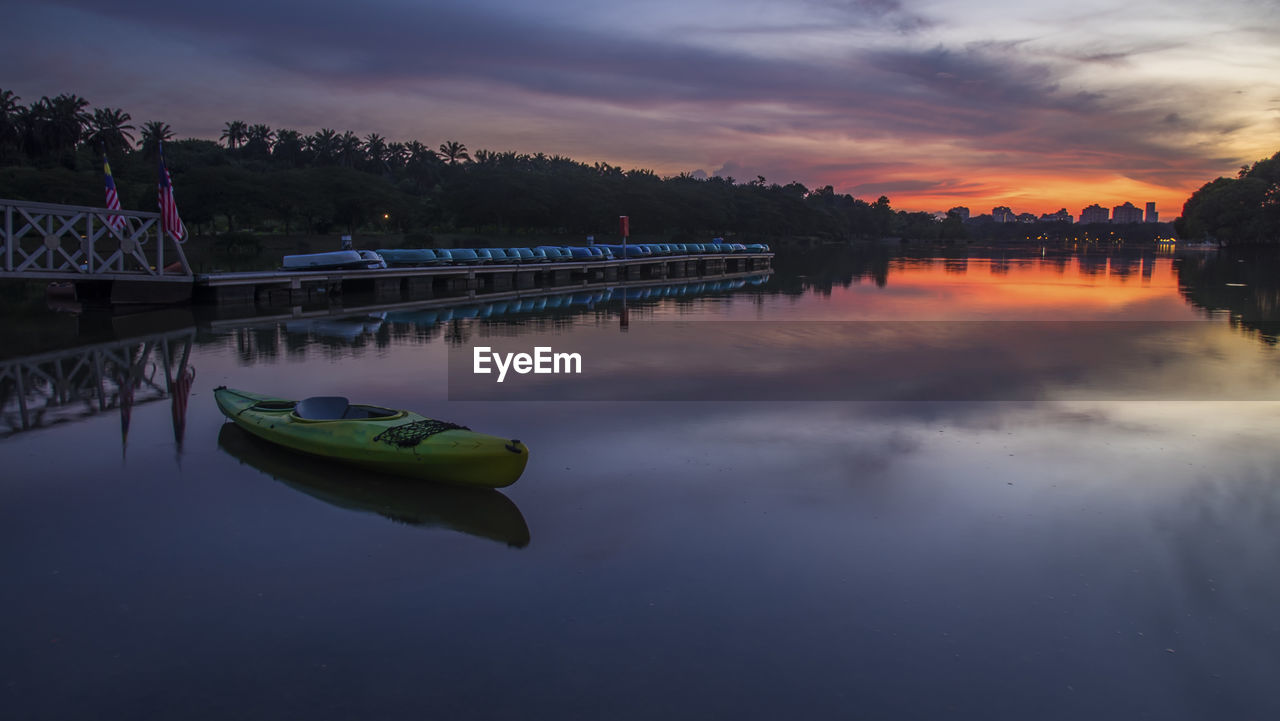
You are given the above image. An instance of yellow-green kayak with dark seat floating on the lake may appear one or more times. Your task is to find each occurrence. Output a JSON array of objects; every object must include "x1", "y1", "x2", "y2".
[{"x1": 214, "y1": 385, "x2": 529, "y2": 488}]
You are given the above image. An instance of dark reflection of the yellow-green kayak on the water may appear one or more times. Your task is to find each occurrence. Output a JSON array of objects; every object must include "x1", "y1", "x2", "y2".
[{"x1": 218, "y1": 423, "x2": 529, "y2": 548}]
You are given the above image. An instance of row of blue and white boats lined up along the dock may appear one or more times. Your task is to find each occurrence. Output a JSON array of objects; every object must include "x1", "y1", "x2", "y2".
[{"x1": 284, "y1": 238, "x2": 771, "y2": 270}]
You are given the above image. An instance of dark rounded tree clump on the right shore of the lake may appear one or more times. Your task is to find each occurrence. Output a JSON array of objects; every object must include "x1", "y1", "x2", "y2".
[{"x1": 1178, "y1": 152, "x2": 1280, "y2": 245}]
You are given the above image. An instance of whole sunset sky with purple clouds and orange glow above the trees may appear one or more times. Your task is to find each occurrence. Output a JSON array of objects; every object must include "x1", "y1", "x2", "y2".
[{"x1": 0, "y1": 0, "x2": 1280, "y2": 219}]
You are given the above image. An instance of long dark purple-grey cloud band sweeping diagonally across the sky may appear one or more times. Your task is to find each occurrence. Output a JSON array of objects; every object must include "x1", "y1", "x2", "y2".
[{"x1": 15, "y1": 0, "x2": 1259, "y2": 189}]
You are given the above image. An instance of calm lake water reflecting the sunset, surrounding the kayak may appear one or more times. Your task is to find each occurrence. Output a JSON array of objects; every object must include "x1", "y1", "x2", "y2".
[{"x1": 0, "y1": 248, "x2": 1280, "y2": 720}]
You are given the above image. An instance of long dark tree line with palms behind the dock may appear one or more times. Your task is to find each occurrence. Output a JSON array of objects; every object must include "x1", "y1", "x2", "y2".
[{"x1": 0, "y1": 91, "x2": 964, "y2": 239}]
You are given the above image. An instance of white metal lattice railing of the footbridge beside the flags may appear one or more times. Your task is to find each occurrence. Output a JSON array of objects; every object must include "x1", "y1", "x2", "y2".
[{"x1": 0, "y1": 198, "x2": 192, "y2": 282}]
